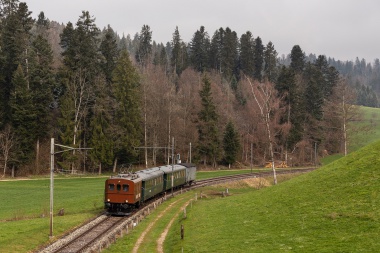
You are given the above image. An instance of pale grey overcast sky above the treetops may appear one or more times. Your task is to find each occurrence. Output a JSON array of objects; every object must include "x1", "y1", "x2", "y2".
[{"x1": 25, "y1": 0, "x2": 380, "y2": 62}]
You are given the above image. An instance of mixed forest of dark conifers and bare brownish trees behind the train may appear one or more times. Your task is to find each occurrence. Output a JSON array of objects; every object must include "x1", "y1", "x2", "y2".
[{"x1": 0, "y1": 0, "x2": 380, "y2": 177}]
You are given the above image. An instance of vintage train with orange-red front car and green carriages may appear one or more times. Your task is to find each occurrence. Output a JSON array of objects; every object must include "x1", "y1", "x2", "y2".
[{"x1": 104, "y1": 163, "x2": 197, "y2": 215}]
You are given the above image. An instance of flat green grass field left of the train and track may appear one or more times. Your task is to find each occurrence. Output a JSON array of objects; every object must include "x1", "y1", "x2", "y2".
[{"x1": 0, "y1": 178, "x2": 105, "y2": 252}]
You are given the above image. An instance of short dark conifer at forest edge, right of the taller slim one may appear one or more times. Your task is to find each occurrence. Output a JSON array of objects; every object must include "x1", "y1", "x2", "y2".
[{"x1": 223, "y1": 121, "x2": 240, "y2": 168}]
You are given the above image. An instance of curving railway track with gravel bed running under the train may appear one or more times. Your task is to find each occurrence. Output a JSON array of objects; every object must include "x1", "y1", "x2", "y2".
[{"x1": 39, "y1": 168, "x2": 314, "y2": 253}]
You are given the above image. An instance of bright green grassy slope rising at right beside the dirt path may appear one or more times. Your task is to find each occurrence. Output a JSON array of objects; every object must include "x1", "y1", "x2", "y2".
[{"x1": 172, "y1": 142, "x2": 380, "y2": 252}]
